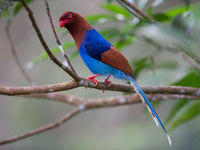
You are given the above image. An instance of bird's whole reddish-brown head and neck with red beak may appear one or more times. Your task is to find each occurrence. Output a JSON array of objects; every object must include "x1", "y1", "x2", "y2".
[{"x1": 59, "y1": 11, "x2": 92, "y2": 48}]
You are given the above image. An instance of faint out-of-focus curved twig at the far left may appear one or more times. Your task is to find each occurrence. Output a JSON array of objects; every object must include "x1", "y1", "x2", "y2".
[{"x1": 5, "y1": 20, "x2": 34, "y2": 85}]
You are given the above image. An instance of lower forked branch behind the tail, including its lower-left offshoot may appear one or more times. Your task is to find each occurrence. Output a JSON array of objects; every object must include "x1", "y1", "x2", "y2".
[{"x1": 0, "y1": 93, "x2": 200, "y2": 145}]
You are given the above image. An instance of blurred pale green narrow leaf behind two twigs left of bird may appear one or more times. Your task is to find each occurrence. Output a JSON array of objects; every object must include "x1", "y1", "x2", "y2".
[{"x1": 33, "y1": 42, "x2": 75, "y2": 64}]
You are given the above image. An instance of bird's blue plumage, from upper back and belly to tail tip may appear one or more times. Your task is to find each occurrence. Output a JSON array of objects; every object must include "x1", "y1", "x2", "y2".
[{"x1": 79, "y1": 29, "x2": 171, "y2": 145}]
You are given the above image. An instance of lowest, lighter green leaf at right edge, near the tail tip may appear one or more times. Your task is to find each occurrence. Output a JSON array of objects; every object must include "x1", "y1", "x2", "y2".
[{"x1": 168, "y1": 101, "x2": 200, "y2": 131}]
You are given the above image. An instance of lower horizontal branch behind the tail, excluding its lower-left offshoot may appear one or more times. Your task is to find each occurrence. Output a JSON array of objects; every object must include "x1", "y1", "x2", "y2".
[{"x1": 30, "y1": 93, "x2": 200, "y2": 109}]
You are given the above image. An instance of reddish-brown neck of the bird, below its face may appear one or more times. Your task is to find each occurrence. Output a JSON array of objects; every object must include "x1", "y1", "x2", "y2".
[{"x1": 66, "y1": 22, "x2": 92, "y2": 50}]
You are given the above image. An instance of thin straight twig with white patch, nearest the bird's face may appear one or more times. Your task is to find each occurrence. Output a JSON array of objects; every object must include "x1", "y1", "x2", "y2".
[{"x1": 44, "y1": 0, "x2": 78, "y2": 76}]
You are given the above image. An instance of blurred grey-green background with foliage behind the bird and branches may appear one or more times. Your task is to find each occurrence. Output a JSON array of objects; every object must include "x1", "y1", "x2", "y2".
[{"x1": 0, "y1": 0, "x2": 200, "y2": 150}]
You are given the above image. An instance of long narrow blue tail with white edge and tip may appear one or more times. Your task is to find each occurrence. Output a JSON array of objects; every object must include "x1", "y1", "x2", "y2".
[{"x1": 127, "y1": 75, "x2": 172, "y2": 146}]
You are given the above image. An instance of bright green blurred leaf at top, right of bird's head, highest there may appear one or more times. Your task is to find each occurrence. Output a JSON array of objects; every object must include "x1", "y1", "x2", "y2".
[{"x1": 101, "y1": 4, "x2": 132, "y2": 18}]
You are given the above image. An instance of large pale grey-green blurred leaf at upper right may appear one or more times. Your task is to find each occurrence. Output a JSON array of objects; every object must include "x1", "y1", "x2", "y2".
[{"x1": 137, "y1": 24, "x2": 199, "y2": 57}]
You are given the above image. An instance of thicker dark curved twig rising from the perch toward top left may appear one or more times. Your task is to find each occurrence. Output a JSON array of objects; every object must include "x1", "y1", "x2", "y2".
[{"x1": 21, "y1": 0, "x2": 80, "y2": 81}]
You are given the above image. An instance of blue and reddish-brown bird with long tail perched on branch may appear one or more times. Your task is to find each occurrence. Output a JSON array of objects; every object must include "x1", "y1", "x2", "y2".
[{"x1": 59, "y1": 11, "x2": 172, "y2": 146}]
